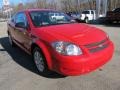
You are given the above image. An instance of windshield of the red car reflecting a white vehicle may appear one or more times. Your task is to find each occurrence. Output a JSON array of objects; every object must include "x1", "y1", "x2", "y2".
[{"x1": 30, "y1": 11, "x2": 75, "y2": 27}]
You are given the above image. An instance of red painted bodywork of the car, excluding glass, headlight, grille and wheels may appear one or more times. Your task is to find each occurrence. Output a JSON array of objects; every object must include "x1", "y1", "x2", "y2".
[{"x1": 8, "y1": 9, "x2": 114, "y2": 75}]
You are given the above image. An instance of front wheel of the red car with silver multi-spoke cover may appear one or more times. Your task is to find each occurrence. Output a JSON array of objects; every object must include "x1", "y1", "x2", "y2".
[{"x1": 32, "y1": 47, "x2": 49, "y2": 75}]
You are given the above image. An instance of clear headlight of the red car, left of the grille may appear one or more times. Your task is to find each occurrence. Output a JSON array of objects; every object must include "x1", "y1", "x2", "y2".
[{"x1": 52, "y1": 41, "x2": 82, "y2": 56}]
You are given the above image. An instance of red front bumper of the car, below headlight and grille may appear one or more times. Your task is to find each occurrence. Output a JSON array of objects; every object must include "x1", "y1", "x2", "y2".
[{"x1": 53, "y1": 42, "x2": 114, "y2": 76}]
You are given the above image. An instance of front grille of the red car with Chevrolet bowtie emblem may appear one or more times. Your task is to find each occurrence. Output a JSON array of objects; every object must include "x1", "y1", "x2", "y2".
[{"x1": 85, "y1": 39, "x2": 109, "y2": 53}]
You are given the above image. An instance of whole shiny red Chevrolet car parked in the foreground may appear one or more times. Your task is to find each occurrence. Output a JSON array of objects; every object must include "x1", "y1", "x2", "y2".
[{"x1": 8, "y1": 9, "x2": 114, "y2": 76}]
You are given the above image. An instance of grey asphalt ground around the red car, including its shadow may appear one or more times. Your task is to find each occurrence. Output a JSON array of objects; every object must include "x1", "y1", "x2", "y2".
[{"x1": 0, "y1": 22, "x2": 120, "y2": 90}]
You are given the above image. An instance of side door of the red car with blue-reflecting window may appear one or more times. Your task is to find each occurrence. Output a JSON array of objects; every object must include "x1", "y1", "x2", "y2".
[{"x1": 15, "y1": 12, "x2": 31, "y2": 50}]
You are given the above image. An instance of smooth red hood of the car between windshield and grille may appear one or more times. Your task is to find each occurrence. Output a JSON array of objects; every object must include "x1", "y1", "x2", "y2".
[{"x1": 36, "y1": 23, "x2": 106, "y2": 45}]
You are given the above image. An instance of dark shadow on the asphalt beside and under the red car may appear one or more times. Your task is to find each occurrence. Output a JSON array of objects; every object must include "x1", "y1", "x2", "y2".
[{"x1": 0, "y1": 37, "x2": 65, "y2": 79}]
